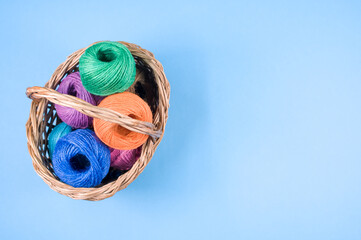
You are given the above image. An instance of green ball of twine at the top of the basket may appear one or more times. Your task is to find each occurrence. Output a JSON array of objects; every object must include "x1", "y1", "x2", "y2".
[{"x1": 79, "y1": 42, "x2": 136, "y2": 96}]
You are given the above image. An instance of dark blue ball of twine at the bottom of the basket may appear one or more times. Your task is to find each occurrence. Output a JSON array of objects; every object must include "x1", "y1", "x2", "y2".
[{"x1": 52, "y1": 129, "x2": 110, "y2": 187}]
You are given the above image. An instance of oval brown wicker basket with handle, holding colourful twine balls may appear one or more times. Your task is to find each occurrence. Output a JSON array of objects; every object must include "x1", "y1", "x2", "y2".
[{"x1": 26, "y1": 42, "x2": 170, "y2": 201}]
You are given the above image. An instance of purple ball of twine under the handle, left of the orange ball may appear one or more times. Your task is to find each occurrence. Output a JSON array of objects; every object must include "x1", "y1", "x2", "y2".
[{"x1": 55, "y1": 72, "x2": 96, "y2": 128}]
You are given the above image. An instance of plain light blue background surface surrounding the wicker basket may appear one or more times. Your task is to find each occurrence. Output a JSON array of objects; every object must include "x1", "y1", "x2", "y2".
[{"x1": 0, "y1": 0, "x2": 361, "y2": 240}]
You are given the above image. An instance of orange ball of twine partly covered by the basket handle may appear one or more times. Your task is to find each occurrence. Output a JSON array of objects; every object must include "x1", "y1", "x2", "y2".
[{"x1": 93, "y1": 92, "x2": 153, "y2": 150}]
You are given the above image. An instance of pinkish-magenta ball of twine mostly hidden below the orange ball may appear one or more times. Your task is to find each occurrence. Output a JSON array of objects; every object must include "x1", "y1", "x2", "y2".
[{"x1": 110, "y1": 146, "x2": 142, "y2": 170}]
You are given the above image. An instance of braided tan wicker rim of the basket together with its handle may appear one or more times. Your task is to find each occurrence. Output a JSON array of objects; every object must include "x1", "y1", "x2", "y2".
[{"x1": 26, "y1": 41, "x2": 170, "y2": 201}]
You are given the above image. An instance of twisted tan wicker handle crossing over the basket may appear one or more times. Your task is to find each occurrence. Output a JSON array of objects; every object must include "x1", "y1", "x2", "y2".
[{"x1": 26, "y1": 87, "x2": 162, "y2": 140}]
